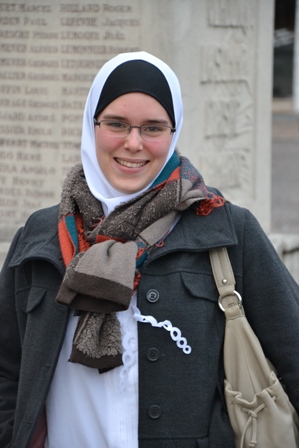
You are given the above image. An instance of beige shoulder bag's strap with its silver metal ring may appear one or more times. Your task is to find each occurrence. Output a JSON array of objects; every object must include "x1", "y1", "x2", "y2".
[{"x1": 209, "y1": 247, "x2": 242, "y2": 312}]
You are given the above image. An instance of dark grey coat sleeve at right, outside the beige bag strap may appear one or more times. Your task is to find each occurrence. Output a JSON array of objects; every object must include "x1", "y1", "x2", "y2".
[{"x1": 234, "y1": 211, "x2": 299, "y2": 414}]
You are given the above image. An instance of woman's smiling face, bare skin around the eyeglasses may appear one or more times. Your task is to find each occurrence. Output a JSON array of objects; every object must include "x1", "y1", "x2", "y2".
[{"x1": 95, "y1": 92, "x2": 172, "y2": 194}]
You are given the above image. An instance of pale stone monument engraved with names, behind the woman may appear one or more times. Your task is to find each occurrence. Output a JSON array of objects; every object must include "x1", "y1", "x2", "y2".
[{"x1": 0, "y1": 0, "x2": 274, "y2": 266}]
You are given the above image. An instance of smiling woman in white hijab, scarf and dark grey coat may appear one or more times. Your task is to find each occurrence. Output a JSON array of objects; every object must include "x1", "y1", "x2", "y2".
[{"x1": 0, "y1": 52, "x2": 299, "y2": 448}]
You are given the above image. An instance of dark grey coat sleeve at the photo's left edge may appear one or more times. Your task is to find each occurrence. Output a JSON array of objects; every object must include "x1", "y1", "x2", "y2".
[{"x1": 0, "y1": 230, "x2": 22, "y2": 448}]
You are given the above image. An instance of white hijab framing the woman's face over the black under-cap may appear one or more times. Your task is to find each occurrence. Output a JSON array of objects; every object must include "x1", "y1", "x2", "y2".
[{"x1": 81, "y1": 51, "x2": 183, "y2": 216}]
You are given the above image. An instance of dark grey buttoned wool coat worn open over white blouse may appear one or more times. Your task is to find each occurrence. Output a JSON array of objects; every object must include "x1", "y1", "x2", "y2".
[{"x1": 0, "y1": 204, "x2": 299, "y2": 448}]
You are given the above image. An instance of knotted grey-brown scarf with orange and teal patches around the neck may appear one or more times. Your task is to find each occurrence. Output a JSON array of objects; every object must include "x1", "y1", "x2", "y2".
[{"x1": 56, "y1": 152, "x2": 224, "y2": 373}]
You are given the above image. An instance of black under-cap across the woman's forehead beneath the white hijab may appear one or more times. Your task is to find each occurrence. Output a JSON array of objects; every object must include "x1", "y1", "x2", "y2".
[{"x1": 94, "y1": 59, "x2": 175, "y2": 126}]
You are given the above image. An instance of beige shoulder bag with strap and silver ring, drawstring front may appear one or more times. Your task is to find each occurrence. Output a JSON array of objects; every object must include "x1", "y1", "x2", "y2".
[{"x1": 210, "y1": 248, "x2": 299, "y2": 448}]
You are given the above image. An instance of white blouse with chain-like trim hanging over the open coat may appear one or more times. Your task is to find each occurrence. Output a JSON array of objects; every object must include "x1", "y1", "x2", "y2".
[{"x1": 45, "y1": 293, "x2": 191, "y2": 448}]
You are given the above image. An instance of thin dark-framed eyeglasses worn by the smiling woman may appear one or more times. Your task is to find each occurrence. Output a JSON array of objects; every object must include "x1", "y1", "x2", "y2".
[{"x1": 94, "y1": 119, "x2": 176, "y2": 142}]
